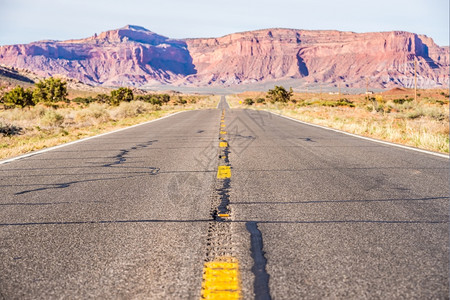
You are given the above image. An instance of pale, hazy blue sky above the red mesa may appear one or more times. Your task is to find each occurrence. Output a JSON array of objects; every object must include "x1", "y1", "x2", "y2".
[{"x1": 0, "y1": 0, "x2": 450, "y2": 46}]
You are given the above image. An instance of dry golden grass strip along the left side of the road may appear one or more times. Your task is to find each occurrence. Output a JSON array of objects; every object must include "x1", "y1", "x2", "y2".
[{"x1": 0, "y1": 96, "x2": 219, "y2": 159}]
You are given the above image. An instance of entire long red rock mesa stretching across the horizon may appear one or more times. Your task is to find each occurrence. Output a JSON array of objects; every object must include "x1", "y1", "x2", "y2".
[{"x1": 0, "y1": 25, "x2": 449, "y2": 88}]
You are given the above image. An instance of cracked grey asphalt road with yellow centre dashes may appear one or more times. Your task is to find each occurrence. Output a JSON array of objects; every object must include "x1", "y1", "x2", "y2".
[{"x1": 0, "y1": 99, "x2": 449, "y2": 299}]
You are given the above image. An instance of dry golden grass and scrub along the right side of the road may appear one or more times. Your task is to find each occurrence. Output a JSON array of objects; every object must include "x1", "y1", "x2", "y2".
[{"x1": 228, "y1": 90, "x2": 449, "y2": 153}]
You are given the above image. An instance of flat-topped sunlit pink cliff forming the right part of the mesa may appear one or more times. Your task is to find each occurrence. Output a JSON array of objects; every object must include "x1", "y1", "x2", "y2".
[{"x1": 186, "y1": 29, "x2": 449, "y2": 87}]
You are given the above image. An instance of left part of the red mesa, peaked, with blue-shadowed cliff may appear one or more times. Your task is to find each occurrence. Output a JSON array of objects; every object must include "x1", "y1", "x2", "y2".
[{"x1": 0, "y1": 26, "x2": 195, "y2": 86}]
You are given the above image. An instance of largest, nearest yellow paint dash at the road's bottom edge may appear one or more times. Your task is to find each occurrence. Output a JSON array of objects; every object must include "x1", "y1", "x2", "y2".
[{"x1": 201, "y1": 256, "x2": 241, "y2": 300}]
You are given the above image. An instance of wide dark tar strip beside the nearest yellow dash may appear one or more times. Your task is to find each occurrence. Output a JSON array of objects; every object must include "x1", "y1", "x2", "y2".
[{"x1": 245, "y1": 222, "x2": 272, "y2": 300}]
